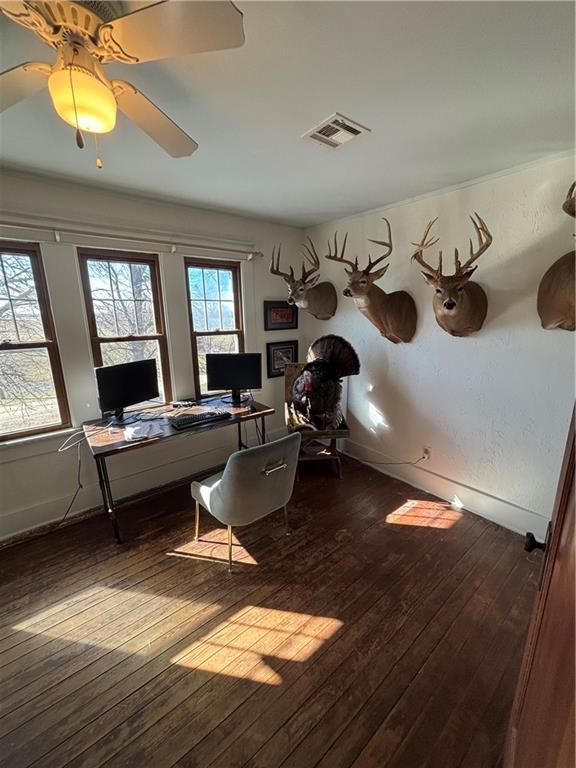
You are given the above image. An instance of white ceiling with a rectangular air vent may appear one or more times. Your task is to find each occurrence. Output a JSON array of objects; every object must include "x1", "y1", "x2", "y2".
[{"x1": 0, "y1": 2, "x2": 574, "y2": 226}]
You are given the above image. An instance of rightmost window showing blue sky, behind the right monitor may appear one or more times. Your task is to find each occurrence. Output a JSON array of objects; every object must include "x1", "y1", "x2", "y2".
[{"x1": 185, "y1": 259, "x2": 244, "y2": 397}]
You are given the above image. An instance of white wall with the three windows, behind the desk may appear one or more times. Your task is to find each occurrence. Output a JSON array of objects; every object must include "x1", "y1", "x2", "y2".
[{"x1": 0, "y1": 172, "x2": 304, "y2": 537}]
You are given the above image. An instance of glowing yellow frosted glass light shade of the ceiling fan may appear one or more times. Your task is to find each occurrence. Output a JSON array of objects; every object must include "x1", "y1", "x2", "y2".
[{"x1": 48, "y1": 67, "x2": 116, "y2": 133}]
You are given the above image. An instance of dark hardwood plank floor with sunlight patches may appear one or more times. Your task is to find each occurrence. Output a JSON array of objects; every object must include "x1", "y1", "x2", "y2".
[{"x1": 0, "y1": 460, "x2": 541, "y2": 768}]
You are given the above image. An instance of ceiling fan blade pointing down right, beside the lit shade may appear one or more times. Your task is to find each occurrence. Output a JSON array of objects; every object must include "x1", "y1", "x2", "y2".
[{"x1": 112, "y1": 80, "x2": 198, "y2": 157}]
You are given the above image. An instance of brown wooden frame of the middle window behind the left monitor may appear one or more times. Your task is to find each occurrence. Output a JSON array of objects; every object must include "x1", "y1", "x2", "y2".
[{"x1": 77, "y1": 248, "x2": 172, "y2": 403}]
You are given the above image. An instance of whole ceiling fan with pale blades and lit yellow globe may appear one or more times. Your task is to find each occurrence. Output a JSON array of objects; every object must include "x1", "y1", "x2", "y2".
[{"x1": 0, "y1": 0, "x2": 244, "y2": 159}]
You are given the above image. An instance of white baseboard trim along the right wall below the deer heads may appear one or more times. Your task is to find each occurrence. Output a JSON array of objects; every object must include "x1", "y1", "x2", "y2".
[{"x1": 341, "y1": 439, "x2": 548, "y2": 540}]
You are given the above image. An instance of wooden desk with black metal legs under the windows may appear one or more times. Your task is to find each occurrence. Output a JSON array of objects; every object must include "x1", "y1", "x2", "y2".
[{"x1": 83, "y1": 400, "x2": 274, "y2": 543}]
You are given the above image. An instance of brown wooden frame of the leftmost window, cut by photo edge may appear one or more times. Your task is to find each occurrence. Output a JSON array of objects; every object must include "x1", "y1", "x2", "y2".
[{"x1": 0, "y1": 240, "x2": 72, "y2": 442}]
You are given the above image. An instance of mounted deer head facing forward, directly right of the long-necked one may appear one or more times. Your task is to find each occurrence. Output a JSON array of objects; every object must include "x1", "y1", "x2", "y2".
[{"x1": 412, "y1": 213, "x2": 492, "y2": 336}]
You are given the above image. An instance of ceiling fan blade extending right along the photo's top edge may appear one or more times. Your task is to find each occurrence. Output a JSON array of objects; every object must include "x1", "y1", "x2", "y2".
[{"x1": 98, "y1": 0, "x2": 244, "y2": 63}]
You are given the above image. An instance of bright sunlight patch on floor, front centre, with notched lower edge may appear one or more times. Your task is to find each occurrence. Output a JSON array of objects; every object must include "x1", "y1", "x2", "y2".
[{"x1": 170, "y1": 608, "x2": 343, "y2": 685}]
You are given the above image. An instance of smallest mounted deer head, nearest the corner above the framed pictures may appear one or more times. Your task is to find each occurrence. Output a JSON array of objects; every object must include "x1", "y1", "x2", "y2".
[{"x1": 270, "y1": 243, "x2": 338, "y2": 320}]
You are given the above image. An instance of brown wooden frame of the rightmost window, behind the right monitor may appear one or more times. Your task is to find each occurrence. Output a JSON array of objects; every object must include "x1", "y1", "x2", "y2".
[{"x1": 184, "y1": 256, "x2": 245, "y2": 400}]
